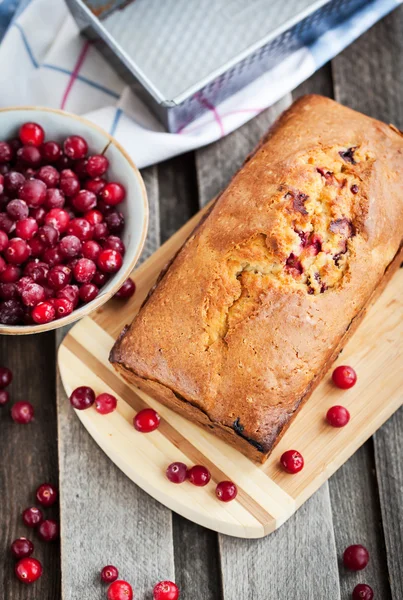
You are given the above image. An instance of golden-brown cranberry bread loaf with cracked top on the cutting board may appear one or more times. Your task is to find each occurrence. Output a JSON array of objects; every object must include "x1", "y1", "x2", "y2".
[{"x1": 110, "y1": 96, "x2": 403, "y2": 462}]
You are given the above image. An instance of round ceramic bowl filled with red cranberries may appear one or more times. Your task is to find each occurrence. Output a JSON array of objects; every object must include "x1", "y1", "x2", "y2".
[{"x1": 0, "y1": 108, "x2": 148, "y2": 334}]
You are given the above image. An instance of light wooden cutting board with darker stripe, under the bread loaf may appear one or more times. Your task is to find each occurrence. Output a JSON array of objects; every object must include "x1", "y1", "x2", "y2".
[{"x1": 58, "y1": 206, "x2": 403, "y2": 538}]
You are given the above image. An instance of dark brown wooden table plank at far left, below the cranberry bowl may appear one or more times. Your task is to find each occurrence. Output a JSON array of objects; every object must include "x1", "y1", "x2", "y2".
[{"x1": 0, "y1": 332, "x2": 60, "y2": 600}]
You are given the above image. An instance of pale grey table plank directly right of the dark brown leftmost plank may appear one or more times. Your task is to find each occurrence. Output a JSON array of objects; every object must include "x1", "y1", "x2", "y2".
[{"x1": 54, "y1": 167, "x2": 174, "y2": 600}]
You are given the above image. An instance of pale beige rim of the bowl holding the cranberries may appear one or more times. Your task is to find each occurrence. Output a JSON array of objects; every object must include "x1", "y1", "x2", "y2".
[{"x1": 0, "y1": 106, "x2": 149, "y2": 335}]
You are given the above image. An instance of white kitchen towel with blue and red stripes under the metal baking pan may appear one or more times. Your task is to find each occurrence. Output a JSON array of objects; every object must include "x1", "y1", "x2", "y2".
[{"x1": 0, "y1": 0, "x2": 403, "y2": 167}]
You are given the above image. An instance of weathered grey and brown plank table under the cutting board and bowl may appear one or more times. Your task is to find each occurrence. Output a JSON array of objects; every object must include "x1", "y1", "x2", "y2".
[{"x1": 0, "y1": 7, "x2": 403, "y2": 600}]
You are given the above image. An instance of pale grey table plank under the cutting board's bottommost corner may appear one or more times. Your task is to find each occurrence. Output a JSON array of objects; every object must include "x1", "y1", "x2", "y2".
[{"x1": 196, "y1": 96, "x2": 340, "y2": 600}]
